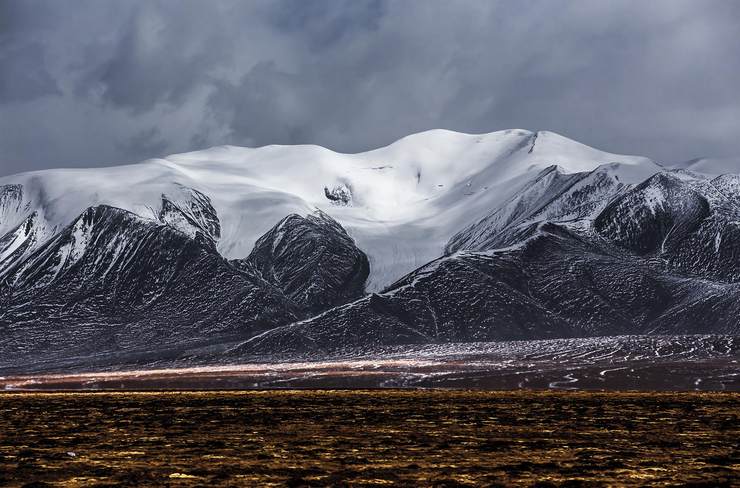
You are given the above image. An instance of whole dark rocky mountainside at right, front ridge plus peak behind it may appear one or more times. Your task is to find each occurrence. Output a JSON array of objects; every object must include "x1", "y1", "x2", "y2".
[{"x1": 234, "y1": 173, "x2": 740, "y2": 356}]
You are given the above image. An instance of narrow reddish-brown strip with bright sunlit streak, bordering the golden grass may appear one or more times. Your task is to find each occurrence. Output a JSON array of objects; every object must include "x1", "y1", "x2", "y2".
[{"x1": 0, "y1": 357, "x2": 740, "y2": 391}]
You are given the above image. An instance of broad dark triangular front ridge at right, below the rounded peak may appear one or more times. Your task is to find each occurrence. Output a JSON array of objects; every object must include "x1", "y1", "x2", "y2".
[{"x1": 234, "y1": 224, "x2": 740, "y2": 356}]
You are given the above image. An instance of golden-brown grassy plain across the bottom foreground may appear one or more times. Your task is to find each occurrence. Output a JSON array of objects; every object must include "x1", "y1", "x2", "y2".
[{"x1": 0, "y1": 390, "x2": 740, "y2": 486}]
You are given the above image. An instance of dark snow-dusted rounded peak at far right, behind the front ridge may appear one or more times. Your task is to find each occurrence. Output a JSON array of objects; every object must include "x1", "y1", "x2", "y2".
[{"x1": 594, "y1": 172, "x2": 740, "y2": 283}]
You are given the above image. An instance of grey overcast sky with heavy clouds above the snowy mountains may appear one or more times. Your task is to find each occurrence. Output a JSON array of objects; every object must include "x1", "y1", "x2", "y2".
[{"x1": 0, "y1": 0, "x2": 740, "y2": 175}]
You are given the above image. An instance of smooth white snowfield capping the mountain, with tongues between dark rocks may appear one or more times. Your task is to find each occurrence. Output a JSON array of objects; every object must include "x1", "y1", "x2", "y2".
[{"x1": 0, "y1": 129, "x2": 662, "y2": 291}]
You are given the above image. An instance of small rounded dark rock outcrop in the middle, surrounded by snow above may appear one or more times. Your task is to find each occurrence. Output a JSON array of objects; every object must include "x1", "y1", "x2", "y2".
[{"x1": 237, "y1": 211, "x2": 370, "y2": 314}]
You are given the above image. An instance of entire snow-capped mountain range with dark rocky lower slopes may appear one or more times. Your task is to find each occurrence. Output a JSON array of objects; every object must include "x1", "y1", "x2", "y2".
[{"x1": 0, "y1": 130, "x2": 740, "y2": 371}]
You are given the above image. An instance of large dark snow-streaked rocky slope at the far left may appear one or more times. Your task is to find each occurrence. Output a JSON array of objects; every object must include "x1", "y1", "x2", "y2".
[{"x1": 0, "y1": 206, "x2": 300, "y2": 363}]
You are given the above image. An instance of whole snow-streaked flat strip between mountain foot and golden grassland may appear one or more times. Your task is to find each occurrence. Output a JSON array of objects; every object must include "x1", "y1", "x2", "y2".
[{"x1": 0, "y1": 335, "x2": 740, "y2": 391}]
